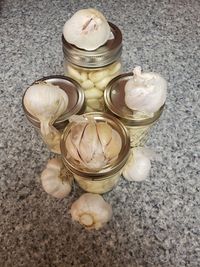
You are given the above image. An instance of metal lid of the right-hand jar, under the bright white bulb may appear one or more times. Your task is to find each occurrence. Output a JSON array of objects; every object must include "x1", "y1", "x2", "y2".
[{"x1": 104, "y1": 72, "x2": 164, "y2": 126}]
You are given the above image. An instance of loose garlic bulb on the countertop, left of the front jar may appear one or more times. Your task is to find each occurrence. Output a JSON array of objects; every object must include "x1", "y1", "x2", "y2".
[{"x1": 41, "y1": 158, "x2": 73, "y2": 198}]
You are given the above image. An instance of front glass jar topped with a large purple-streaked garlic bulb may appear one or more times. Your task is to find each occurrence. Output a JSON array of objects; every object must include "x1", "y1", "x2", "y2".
[{"x1": 61, "y1": 112, "x2": 130, "y2": 194}]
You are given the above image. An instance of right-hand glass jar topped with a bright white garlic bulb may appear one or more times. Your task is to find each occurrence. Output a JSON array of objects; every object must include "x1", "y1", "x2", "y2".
[{"x1": 104, "y1": 67, "x2": 167, "y2": 147}]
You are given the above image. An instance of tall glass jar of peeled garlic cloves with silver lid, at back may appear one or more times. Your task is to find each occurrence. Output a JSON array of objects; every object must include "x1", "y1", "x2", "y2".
[{"x1": 62, "y1": 22, "x2": 122, "y2": 112}]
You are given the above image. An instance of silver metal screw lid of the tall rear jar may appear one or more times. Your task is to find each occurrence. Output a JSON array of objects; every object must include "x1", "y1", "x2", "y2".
[{"x1": 62, "y1": 22, "x2": 122, "y2": 68}]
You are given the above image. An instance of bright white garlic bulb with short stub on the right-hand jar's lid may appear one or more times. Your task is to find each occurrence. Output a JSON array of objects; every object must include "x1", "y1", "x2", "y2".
[{"x1": 125, "y1": 67, "x2": 167, "y2": 114}]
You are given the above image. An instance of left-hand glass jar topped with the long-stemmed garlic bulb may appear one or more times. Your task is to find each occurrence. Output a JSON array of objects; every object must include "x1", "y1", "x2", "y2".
[{"x1": 22, "y1": 75, "x2": 85, "y2": 154}]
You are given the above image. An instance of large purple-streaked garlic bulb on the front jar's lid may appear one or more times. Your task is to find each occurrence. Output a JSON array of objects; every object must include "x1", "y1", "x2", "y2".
[{"x1": 66, "y1": 116, "x2": 122, "y2": 170}]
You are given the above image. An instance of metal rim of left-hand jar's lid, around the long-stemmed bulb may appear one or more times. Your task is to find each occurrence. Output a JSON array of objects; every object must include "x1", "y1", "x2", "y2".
[{"x1": 22, "y1": 75, "x2": 85, "y2": 128}]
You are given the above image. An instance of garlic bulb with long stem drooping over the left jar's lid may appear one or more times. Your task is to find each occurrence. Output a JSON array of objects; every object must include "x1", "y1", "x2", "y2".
[{"x1": 24, "y1": 82, "x2": 68, "y2": 153}]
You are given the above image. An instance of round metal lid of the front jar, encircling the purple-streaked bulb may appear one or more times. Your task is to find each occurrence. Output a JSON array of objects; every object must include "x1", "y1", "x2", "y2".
[{"x1": 61, "y1": 112, "x2": 130, "y2": 180}]
